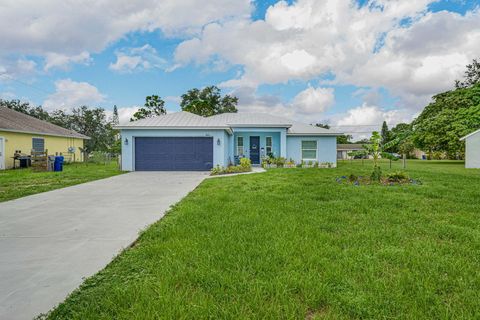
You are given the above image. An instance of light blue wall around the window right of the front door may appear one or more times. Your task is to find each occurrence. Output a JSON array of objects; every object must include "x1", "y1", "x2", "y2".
[{"x1": 287, "y1": 136, "x2": 337, "y2": 166}]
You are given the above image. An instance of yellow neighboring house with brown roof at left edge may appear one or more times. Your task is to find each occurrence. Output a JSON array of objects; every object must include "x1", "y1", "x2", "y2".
[{"x1": 0, "y1": 107, "x2": 90, "y2": 170}]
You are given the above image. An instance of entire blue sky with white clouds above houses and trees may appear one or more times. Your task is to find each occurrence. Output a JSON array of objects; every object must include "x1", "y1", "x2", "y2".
[{"x1": 0, "y1": 0, "x2": 480, "y2": 131}]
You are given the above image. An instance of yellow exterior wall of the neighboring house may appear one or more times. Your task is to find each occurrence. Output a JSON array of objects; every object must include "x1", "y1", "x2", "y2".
[{"x1": 0, "y1": 131, "x2": 84, "y2": 169}]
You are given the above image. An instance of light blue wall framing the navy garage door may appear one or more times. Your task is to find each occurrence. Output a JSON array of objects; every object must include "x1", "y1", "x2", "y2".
[{"x1": 121, "y1": 129, "x2": 229, "y2": 171}]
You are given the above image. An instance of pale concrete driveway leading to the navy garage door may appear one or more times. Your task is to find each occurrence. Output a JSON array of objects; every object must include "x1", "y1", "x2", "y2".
[{"x1": 0, "y1": 172, "x2": 208, "y2": 319}]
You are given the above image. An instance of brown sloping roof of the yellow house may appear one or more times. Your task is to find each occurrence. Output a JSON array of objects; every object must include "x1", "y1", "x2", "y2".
[{"x1": 0, "y1": 107, "x2": 90, "y2": 139}]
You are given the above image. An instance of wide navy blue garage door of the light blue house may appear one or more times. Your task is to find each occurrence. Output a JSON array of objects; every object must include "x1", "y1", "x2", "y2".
[{"x1": 135, "y1": 137, "x2": 213, "y2": 171}]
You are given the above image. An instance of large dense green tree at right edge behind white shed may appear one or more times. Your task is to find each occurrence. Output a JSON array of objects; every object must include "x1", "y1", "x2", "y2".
[{"x1": 412, "y1": 84, "x2": 480, "y2": 158}]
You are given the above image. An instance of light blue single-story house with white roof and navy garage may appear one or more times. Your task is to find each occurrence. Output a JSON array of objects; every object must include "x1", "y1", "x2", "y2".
[{"x1": 117, "y1": 112, "x2": 341, "y2": 171}]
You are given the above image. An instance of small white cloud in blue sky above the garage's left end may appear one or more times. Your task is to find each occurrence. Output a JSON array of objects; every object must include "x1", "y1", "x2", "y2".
[{"x1": 109, "y1": 44, "x2": 167, "y2": 72}]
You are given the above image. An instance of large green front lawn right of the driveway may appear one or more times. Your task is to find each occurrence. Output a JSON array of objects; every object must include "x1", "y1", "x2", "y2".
[{"x1": 49, "y1": 161, "x2": 480, "y2": 319}]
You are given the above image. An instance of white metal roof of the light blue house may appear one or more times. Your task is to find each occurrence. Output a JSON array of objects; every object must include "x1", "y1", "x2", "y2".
[{"x1": 116, "y1": 111, "x2": 342, "y2": 135}]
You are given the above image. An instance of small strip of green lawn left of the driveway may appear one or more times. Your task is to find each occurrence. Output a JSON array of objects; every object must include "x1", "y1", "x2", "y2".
[{"x1": 0, "y1": 162, "x2": 121, "y2": 202}]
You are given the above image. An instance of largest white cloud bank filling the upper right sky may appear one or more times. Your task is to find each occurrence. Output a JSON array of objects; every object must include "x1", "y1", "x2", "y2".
[{"x1": 175, "y1": 0, "x2": 480, "y2": 111}]
